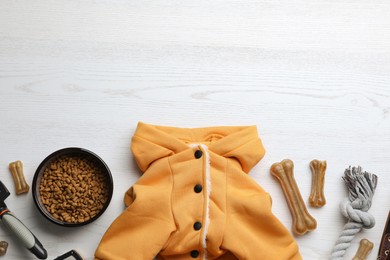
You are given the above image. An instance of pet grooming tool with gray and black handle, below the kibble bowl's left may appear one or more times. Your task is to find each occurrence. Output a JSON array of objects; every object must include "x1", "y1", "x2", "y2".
[{"x1": 0, "y1": 181, "x2": 47, "y2": 259}]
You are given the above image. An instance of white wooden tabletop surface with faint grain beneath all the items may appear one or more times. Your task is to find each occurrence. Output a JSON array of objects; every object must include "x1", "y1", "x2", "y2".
[{"x1": 0, "y1": 0, "x2": 390, "y2": 260}]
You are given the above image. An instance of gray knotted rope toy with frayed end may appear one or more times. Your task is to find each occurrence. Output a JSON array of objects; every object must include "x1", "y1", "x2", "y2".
[{"x1": 331, "y1": 166, "x2": 378, "y2": 260}]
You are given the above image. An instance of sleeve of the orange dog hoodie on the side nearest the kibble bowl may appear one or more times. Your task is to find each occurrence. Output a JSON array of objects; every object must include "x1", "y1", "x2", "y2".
[{"x1": 95, "y1": 160, "x2": 175, "y2": 260}]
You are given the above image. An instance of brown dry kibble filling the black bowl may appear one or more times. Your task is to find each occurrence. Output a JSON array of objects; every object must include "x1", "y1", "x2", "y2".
[{"x1": 39, "y1": 155, "x2": 108, "y2": 223}]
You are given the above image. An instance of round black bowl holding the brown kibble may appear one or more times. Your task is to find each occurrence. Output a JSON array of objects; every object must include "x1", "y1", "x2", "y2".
[{"x1": 32, "y1": 147, "x2": 114, "y2": 227}]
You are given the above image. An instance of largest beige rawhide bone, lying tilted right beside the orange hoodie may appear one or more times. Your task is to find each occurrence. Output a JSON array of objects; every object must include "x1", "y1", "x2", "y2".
[{"x1": 271, "y1": 159, "x2": 317, "y2": 235}]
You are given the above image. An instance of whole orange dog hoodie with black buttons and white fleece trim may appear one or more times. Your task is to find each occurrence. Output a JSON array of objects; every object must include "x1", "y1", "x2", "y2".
[{"x1": 95, "y1": 122, "x2": 301, "y2": 260}]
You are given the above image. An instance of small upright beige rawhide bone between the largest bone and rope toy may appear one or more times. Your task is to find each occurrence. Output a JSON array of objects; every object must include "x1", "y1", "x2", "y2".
[{"x1": 309, "y1": 160, "x2": 326, "y2": 208}]
